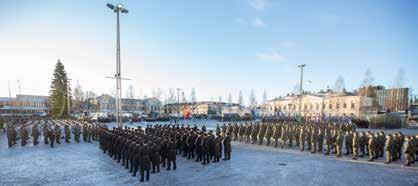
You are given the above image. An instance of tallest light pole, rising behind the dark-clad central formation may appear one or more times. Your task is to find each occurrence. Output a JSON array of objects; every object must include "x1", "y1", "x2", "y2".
[{"x1": 107, "y1": 4, "x2": 128, "y2": 128}]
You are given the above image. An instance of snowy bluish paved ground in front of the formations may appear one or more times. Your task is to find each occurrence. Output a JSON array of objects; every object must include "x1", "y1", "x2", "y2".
[{"x1": 0, "y1": 121, "x2": 418, "y2": 186}]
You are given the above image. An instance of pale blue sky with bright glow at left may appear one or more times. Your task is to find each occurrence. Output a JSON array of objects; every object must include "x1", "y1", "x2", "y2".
[{"x1": 0, "y1": 0, "x2": 418, "y2": 104}]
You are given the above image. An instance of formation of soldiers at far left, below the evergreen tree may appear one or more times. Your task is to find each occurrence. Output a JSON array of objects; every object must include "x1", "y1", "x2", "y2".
[{"x1": 7, "y1": 120, "x2": 101, "y2": 148}]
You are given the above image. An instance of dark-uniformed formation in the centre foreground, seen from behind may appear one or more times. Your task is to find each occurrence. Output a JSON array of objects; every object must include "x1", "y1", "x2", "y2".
[{"x1": 99, "y1": 124, "x2": 231, "y2": 182}]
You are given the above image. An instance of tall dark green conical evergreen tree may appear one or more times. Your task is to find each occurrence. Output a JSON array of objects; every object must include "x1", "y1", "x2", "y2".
[{"x1": 49, "y1": 59, "x2": 71, "y2": 119}]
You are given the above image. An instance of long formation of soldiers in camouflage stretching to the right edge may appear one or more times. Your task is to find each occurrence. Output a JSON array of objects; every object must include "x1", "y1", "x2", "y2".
[{"x1": 216, "y1": 120, "x2": 418, "y2": 166}]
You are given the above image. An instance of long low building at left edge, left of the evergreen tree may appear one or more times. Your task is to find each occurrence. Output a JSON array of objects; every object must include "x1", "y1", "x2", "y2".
[{"x1": 0, "y1": 94, "x2": 50, "y2": 115}]
